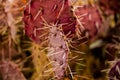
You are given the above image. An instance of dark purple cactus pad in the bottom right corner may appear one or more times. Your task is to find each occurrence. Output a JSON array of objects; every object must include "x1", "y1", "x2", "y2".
[{"x1": 109, "y1": 61, "x2": 120, "y2": 80}]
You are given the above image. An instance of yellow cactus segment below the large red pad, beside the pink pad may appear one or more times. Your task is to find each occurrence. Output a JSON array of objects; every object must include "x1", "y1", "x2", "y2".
[{"x1": 32, "y1": 43, "x2": 50, "y2": 80}]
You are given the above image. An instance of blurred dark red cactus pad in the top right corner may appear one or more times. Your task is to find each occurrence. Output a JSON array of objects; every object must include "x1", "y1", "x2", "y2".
[{"x1": 99, "y1": 0, "x2": 120, "y2": 15}]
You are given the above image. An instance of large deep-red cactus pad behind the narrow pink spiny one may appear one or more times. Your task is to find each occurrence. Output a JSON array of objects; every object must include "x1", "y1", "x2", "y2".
[{"x1": 23, "y1": 0, "x2": 76, "y2": 43}]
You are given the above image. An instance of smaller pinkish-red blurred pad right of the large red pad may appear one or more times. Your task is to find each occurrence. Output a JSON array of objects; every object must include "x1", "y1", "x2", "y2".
[{"x1": 74, "y1": 5, "x2": 102, "y2": 38}]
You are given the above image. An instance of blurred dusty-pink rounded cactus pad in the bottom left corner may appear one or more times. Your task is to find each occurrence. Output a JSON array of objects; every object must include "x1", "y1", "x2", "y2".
[{"x1": 0, "y1": 61, "x2": 26, "y2": 80}]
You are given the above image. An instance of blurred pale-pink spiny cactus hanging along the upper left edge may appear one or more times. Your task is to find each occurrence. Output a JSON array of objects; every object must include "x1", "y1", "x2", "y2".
[{"x1": 0, "y1": 0, "x2": 26, "y2": 59}]
